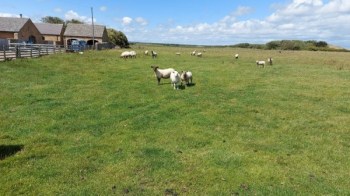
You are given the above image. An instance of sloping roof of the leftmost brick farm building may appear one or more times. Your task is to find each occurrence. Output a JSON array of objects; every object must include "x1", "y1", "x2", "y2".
[{"x1": 0, "y1": 17, "x2": 30, "y2": 32}]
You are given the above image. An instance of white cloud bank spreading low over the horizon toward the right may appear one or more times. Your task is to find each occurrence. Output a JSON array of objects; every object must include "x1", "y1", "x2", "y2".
[{"x1": 122, "y1": 0, "x2": 350, "y2": 48}]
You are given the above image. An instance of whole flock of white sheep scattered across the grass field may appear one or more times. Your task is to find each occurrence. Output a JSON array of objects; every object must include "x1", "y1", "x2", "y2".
[{"x1": 120, "y1": 50, "x2": 273, "y2": 90}]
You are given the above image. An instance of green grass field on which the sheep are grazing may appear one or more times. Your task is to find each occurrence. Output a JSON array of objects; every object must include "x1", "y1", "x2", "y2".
[{"x1": 0, "y1": 45, "x2": 350, "y2": 195}]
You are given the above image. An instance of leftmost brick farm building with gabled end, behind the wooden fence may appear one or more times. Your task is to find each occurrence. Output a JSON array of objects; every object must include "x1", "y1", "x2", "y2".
[{"x1": 0, "y1": 17, "x2": 43, "y2": 44}]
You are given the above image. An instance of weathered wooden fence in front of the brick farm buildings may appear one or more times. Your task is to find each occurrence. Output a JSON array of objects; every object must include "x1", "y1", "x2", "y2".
[{"x1": 0, "y1": 44, "x2": 66, "y2": 61}]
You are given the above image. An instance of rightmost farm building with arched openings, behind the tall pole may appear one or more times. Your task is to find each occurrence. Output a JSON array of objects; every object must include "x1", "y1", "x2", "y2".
[{"x1": 63, "y1": 23, "x2": 108, "y2": 46}]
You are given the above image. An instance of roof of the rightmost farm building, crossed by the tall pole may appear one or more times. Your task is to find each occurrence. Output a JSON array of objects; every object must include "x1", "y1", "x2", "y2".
[{"x1": 64, "y1": 23, "x2": 106, "y2": 38}]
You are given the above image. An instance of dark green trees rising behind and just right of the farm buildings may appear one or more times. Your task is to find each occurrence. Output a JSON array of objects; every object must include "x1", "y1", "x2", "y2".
[{"x1": 41, "y1": 16, "x2": 130, "y2": 48}]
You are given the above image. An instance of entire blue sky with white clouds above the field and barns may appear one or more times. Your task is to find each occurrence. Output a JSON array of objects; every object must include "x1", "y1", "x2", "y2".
[{"x1": 0, "y1": 0, "x2": 350, "y2": 49}]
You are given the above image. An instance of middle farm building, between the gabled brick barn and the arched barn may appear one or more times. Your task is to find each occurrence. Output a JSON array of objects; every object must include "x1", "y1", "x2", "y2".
[{"x1": 35, "y1": 23, "x2": 64, "y2": 45}]
